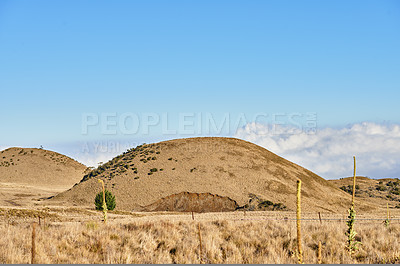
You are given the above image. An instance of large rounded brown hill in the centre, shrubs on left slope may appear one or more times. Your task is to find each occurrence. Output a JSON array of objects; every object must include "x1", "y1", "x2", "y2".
[{"x1": 51, "y1": 137, "x2": 372, "y2": 212}]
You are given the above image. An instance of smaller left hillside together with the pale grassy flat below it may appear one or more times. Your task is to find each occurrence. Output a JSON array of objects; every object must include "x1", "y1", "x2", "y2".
[{"x1": 0, "y1": 148, "x2": 87, "y2": 206}]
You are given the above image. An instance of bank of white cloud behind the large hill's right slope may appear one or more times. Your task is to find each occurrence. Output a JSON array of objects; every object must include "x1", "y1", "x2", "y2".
[{"x1": 235, "y1": 122, "x2": 400, "y2": 179}]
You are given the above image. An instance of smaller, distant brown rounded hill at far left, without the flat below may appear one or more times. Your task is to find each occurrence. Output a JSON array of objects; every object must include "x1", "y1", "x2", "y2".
[{"x1": 0, "y1": 148, "x2": 87, "y2": 190}]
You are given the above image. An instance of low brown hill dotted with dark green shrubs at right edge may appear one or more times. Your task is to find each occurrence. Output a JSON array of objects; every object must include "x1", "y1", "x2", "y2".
[{"x1": 329, "y1": 176, "x2": 400, "y2": 208}]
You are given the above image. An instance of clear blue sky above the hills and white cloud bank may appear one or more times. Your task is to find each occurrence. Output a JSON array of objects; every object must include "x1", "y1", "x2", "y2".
[{"x1": 0, "y1": 0, "x2": 400, "y2": 178}]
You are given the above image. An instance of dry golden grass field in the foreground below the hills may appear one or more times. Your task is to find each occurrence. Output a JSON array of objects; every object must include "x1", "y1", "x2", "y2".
[{"x1": 0, "y1": 208, "x2": 400, "y2": 263}]
